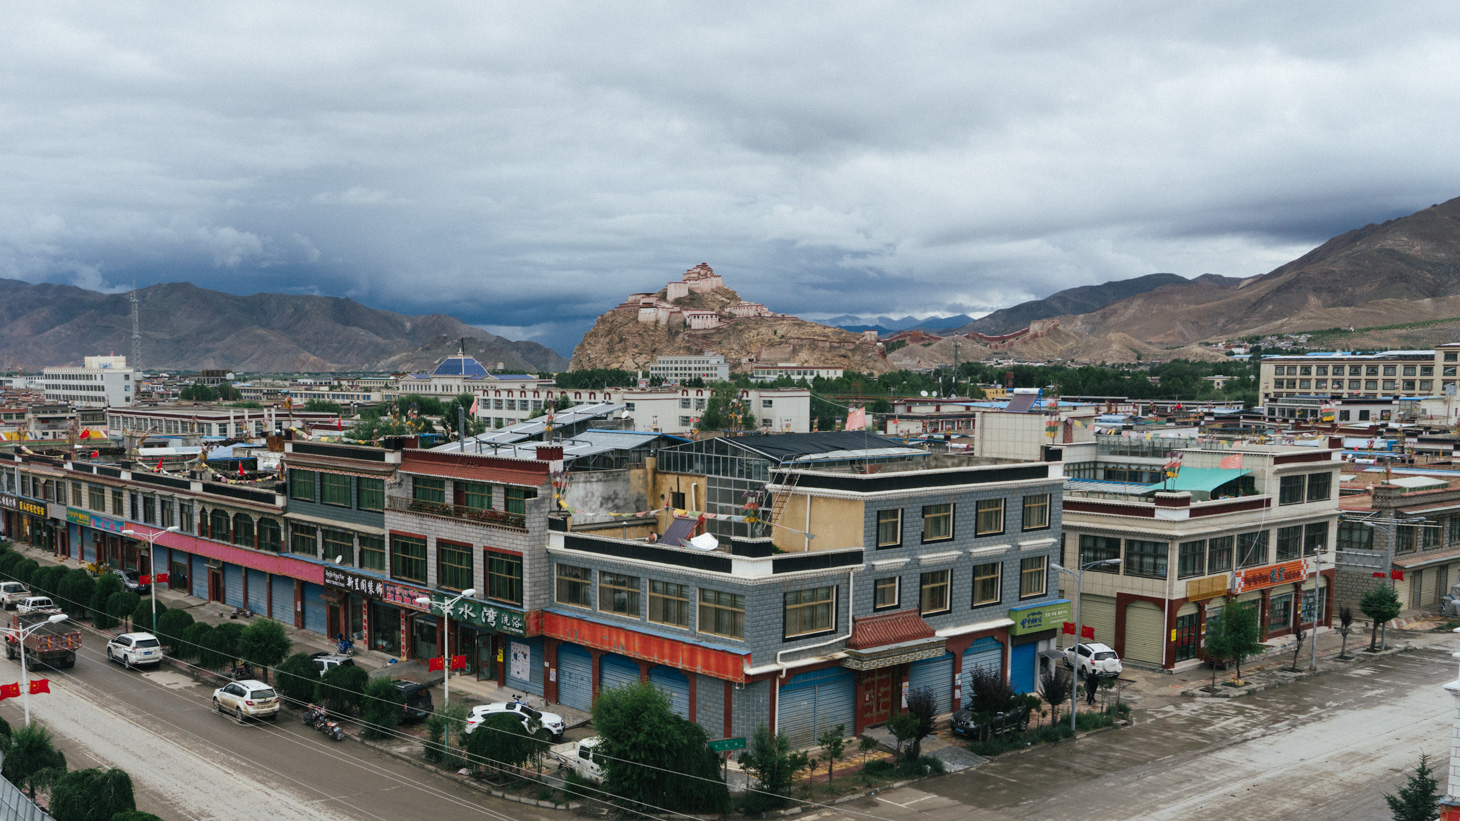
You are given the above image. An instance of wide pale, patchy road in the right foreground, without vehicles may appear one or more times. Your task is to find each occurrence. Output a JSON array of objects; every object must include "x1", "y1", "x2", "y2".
[{"x1": 829, "y1": 650, "x2": 1456, "y2": 821}]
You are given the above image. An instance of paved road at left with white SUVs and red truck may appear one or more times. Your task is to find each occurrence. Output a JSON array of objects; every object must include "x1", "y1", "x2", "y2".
[{"x1": 0, "y1": 634, "x2": 561, "y2": 821}]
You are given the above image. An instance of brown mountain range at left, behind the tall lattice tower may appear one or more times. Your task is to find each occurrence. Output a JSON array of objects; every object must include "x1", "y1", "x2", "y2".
[{"x1": 0, "y1": 279, "x2": 566, "y2": 373}]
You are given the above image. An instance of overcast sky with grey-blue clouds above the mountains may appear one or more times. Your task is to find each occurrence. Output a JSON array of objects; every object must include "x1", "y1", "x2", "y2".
[{"x1": 0, "y1": 0, "x2": 1460, "y2": 354}]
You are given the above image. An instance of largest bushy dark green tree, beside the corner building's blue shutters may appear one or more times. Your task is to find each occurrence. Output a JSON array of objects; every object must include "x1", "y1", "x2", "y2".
[{"x1": 593, "y1": 684, "x2": 730, "y2": 812}]
